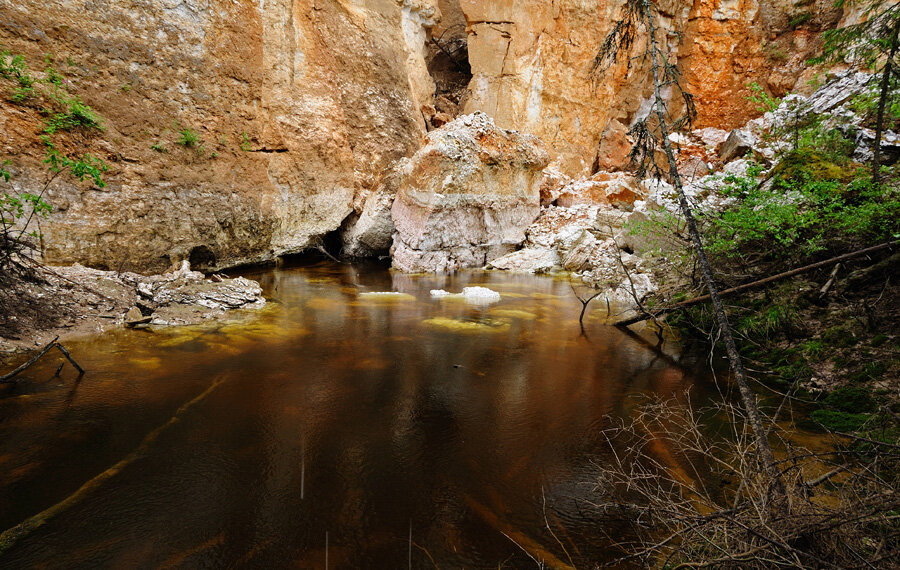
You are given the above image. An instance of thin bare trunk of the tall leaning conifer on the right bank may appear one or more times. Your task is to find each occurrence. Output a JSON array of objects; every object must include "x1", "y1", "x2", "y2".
[{"x1": 643, "y1": 0, "x2": 785, "y2": 498}]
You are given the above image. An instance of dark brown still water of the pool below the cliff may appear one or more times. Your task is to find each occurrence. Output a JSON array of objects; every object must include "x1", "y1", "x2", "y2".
[{"x1": 0, "y1": 263, "x2": 716, "y2": 568}]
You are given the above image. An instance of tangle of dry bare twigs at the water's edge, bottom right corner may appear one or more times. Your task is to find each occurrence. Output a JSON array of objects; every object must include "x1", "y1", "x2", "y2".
[{"x1": 593, "y1": 398, "x2": 900, "y2": 569}]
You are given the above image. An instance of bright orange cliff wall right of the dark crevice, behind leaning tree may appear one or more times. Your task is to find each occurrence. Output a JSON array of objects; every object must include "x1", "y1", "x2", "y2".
[{"x1": 459, "y1": 0, "x2": 840, "y2": 176}]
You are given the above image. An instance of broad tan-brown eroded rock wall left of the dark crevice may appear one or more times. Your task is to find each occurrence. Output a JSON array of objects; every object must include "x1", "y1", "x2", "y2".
[{"x1": 0, "y1": 0, "x2": 440, "y2": 270}]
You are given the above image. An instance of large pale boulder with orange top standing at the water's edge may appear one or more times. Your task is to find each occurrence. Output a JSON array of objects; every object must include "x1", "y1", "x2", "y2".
[{"x1": 391, "y1": 113, "x2": 549, "y2": 272}]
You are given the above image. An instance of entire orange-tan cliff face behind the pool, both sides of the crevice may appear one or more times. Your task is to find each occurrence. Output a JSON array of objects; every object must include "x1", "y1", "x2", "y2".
[{"x1": 0, "y1": 0, "x2": 841, "y2": 271}]
